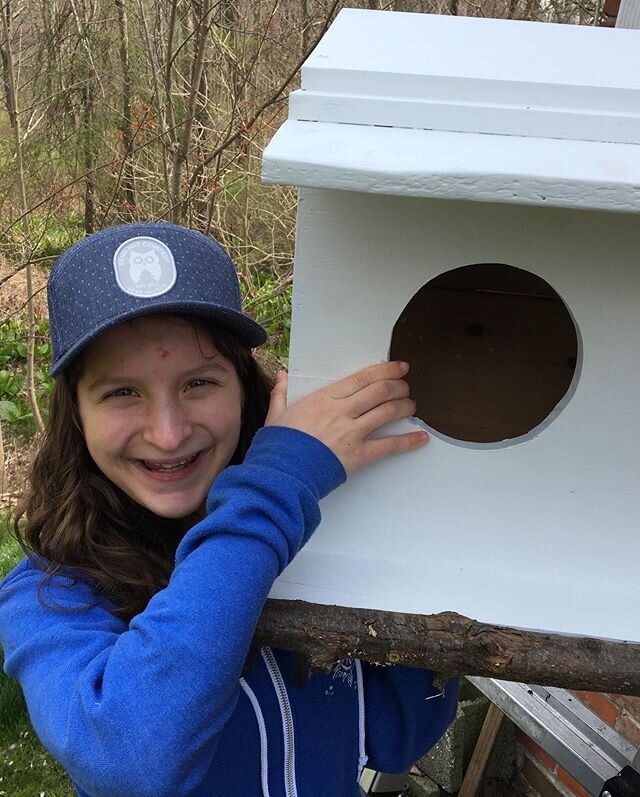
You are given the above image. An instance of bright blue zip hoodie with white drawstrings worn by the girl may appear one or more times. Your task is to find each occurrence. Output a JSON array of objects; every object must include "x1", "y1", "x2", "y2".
[{"x1": 0, "y1": 427, "x2": 457, "y2": 797}]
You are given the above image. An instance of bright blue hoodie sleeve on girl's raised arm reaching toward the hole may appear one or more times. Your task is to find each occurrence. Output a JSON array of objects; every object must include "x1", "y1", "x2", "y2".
[{"x1": 0, "y1": 427, "x2": 346, "y2": 797}]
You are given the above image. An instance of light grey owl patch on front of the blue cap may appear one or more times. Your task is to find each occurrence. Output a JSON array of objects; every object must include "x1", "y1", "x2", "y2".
[{"x1": 113, "y1": 236, "x2": 178, "y2": 298}]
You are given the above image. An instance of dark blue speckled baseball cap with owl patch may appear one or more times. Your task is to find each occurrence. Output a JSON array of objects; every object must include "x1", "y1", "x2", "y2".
[{"x1": 47, "y1": 222, "x2": 267, "y2": 376}]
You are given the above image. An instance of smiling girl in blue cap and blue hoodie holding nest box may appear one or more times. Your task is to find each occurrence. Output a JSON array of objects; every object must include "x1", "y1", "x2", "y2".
[{"x1": 0, "y1": 219, "x2": 456, "y2": 797}]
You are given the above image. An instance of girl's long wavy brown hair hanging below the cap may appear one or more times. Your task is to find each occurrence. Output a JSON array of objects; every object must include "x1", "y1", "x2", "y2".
[{"x1": 13, "y1": 325, "x2": 272, "y2": 621}]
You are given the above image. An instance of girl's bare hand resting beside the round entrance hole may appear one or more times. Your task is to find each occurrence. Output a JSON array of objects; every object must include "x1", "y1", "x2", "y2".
[{"x1": 265, "y1": 362, "x2": 429, "y2": 474}]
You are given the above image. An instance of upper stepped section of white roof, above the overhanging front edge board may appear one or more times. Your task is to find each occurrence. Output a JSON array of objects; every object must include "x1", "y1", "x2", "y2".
[{"x1": 289, "y1": 9, "x2": 640, "y2": 144}]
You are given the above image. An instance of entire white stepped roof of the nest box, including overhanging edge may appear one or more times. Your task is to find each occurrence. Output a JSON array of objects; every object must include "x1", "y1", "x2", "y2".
[{"x1": 263, "y1": 9, "x2": 640, "y2": 212}]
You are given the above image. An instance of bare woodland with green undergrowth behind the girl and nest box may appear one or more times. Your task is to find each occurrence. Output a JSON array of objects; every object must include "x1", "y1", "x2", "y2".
[{"x1": 0, "y1": 0, "x2": 602, "y2": 797}]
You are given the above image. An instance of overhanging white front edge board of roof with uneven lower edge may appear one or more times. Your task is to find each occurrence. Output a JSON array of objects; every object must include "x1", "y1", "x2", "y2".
[{"x1": 263, "y1": 120, "x2": 640, "y2": 213}]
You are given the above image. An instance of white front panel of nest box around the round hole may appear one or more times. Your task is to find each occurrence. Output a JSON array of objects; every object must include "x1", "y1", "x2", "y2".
[{"x1": 273, "y1": 189, "x2": 640, "y2": 641}]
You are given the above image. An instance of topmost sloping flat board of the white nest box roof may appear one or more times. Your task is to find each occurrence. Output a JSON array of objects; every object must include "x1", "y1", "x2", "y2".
[{"x1": 302, "y1": 9, "x2": 640, "y2": 96}]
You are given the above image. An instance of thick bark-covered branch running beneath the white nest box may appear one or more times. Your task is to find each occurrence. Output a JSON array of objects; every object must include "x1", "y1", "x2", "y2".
[{"x1": 254, "y1": 600, "x2": 640, "y2": 695}]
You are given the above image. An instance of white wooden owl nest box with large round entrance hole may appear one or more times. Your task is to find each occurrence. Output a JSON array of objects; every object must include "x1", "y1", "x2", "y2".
[{"x1": 264, "y1": 10, "x2": 640, "y2": 642}]
